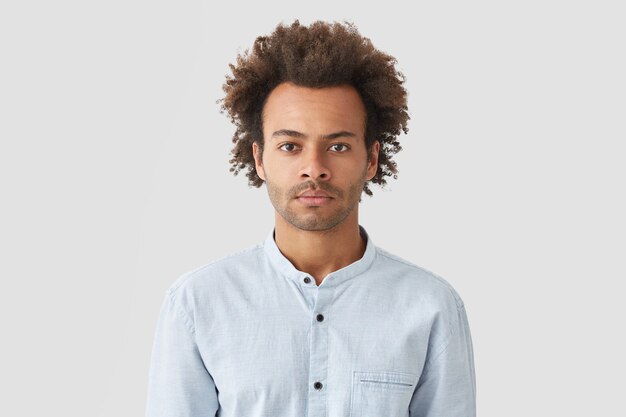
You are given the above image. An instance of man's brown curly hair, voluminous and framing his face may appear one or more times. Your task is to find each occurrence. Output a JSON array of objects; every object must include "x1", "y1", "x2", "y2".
[{"x1": 217, "y1": 20, "x2": 410, "y2": 196}]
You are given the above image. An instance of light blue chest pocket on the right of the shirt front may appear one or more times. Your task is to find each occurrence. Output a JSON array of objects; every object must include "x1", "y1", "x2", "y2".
[{"x1": 350, "y1": 371, "x2": 418, "y2": 417}]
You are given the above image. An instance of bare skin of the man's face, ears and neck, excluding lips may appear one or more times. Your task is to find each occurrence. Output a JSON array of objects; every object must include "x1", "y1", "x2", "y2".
[{"x1": 252, "y1": 82, "x2": 380, "y2": 285}]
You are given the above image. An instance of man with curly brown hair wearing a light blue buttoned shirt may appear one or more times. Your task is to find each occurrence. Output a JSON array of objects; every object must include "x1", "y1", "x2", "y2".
[{"x1": 146, "y1": 21, "x2": 476, "y2": 417}]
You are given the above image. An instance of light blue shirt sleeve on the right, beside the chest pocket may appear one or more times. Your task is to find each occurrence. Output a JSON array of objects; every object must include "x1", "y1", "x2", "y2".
[{"x1": 409, "y1": 305, "x2": 476, "y2": 417}]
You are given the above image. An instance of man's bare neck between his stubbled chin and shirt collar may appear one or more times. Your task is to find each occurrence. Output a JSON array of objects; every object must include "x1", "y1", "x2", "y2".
[{"x1": 274, "y1": 213, "x2": 366, "y2": 285}]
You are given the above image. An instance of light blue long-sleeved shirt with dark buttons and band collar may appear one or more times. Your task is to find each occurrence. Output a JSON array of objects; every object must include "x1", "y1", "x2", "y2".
[{"x1": 146, "y1": 226, "x2": 476, "y2": 417}]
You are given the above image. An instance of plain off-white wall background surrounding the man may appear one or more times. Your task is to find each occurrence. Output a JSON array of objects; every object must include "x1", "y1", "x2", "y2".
[{"x1": 0, "y1": 0, "x2": 626, "y2": 417}]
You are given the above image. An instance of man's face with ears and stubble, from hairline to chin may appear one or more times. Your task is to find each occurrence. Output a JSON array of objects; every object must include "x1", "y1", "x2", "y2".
[{"x1": 253, "y1": 83, "x2": 380, "y2": 231}]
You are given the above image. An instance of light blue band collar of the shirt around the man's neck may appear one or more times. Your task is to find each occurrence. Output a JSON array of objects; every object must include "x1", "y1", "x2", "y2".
[{"x1": 263, "y1": 225, "x2": 376, "y2": 287}]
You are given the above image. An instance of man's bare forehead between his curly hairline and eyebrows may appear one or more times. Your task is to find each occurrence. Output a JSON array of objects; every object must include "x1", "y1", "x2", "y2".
[{"x1": 263, "y1": 82, "x2": 365, "y2": 131}]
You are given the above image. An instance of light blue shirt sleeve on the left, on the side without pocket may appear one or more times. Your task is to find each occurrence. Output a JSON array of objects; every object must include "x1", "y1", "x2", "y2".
[{"x1": 146, "y1": 290, "x2": 219, "y2": 417}]
